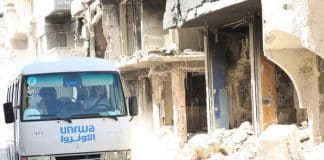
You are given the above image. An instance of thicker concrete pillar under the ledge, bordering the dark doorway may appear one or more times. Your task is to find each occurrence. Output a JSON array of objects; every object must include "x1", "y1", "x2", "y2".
[{"x1": 171, "y1": 65, "x2": 187, "y2": 145}]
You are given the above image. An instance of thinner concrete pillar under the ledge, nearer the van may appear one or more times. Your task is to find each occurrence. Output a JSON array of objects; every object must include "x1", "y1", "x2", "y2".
[{"x1": 151, "y1": 75, "x2": 163, "y2": 133}]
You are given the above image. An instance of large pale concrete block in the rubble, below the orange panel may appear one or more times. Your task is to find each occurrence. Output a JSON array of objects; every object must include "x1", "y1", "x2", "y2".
[{"x1": 259, "y1": 125, "x2": 304, "y2": 160}]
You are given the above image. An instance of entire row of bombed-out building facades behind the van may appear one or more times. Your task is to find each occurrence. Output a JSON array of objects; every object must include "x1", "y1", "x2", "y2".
[{"x1": 5, "y1": 0, "x2": 324, "y2": 156}]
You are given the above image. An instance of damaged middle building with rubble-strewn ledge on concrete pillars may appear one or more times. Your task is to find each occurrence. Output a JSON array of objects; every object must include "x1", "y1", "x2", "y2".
[{"x1": 71, "y1": 0, "x2": 208, "y2": 146}]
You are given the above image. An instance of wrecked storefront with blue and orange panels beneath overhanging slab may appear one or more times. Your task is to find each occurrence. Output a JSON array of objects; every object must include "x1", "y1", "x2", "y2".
[{"x1": 163, "y1": 0, "x2": 307, "y2": 141}]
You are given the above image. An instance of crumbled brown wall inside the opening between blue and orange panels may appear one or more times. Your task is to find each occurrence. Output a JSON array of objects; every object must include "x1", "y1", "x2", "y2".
[{"x1": 226, "y1": 30, "x2": 252, "y2": 128}]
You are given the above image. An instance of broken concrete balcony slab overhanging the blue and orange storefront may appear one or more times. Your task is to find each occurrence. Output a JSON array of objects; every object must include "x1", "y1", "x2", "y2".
[{"x1": 163, "y1": 0, "x2": 260, "y2": 29}]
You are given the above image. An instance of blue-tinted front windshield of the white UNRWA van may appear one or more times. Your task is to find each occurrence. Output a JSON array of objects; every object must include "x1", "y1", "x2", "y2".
[{"x1": 22, "y1": 72, "x2": 126, "y2": 121}]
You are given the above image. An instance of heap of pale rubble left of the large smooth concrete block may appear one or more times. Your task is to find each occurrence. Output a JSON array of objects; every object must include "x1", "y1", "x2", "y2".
[{"x1": 179, "y1": 122, "x2": 257, "y2": 160}]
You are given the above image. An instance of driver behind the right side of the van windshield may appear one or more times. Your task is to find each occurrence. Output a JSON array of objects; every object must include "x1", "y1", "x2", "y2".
[{"x1": 85, "y1": 86, "x2": 108, "y2": 109}]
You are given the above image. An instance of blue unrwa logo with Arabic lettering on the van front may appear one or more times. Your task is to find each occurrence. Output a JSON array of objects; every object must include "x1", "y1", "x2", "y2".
[{"x1": 60, "y1": 125, "x2": 96, "y2": 143}]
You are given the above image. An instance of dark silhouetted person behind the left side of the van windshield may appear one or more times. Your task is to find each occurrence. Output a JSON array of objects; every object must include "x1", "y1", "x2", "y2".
[{"x1": 38, "y1": 87, "x2": 61, "y2": 115}]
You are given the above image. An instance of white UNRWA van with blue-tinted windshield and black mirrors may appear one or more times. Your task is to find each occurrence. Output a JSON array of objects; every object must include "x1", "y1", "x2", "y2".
[{"x1": 4, "y1": 57, "x2": 138, "y2": 160}]
